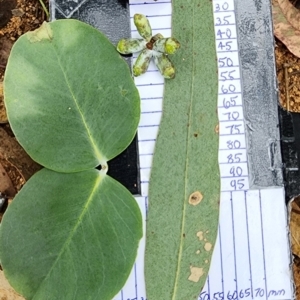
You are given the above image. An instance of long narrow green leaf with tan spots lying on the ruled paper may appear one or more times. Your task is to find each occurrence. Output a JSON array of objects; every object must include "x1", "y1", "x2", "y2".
[{"x1": 145, "y1": 0, "x2": 220, "y2": 300}]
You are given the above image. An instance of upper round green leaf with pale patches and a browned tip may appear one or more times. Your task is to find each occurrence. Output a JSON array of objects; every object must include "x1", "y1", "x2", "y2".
[{"x1": 4, "y1": 20, "x2": 140, "y2": 172}]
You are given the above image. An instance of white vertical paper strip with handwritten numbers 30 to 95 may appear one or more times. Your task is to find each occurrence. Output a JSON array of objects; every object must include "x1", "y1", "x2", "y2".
[{"x1": 213, "y1": 0, "x2": 249, "y2": 191}]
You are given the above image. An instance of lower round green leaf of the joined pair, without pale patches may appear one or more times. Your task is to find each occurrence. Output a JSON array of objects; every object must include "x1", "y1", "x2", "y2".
[{"x1": 0, "y1": 169, "x2": 142, "y2": 300}]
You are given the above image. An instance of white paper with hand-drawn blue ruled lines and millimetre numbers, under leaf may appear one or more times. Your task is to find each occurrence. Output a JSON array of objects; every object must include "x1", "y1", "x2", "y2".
[{"x1": 114, "y1": 0, "x2": 294, "y2": 300}]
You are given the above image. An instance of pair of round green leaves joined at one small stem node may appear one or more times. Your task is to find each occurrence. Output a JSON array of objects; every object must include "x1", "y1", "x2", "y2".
[{"x1": 0, "y1": 20, "x2": 142, "y2": 300}]
